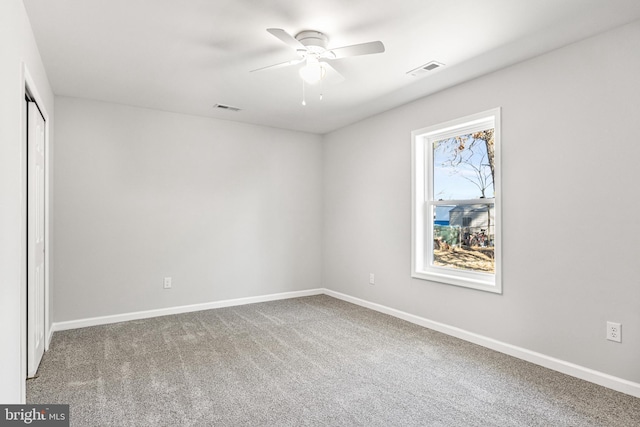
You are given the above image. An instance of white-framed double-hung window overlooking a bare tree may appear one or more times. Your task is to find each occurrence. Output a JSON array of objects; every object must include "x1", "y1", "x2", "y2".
[{"x1": 411, "y1": 109, "x2": 502, "y2": 293}]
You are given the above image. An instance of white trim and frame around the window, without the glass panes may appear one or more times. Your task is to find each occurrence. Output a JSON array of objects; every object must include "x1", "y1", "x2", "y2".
[{"x1": 411, "y1": 108, "x2": 502, "y2": 294}]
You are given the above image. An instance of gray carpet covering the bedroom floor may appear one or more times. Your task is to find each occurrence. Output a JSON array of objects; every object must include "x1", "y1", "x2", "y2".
[{"x1": 27, "y1": 295, "x2": 640, "y2": 427}]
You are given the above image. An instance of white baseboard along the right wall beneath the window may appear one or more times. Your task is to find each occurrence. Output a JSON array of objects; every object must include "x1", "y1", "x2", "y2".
[{"x1": 324, "y1": 289, "x2": 640, "y2": 397}]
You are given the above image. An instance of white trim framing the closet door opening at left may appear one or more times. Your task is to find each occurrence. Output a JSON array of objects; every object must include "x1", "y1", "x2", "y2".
[{"x1": 21, "y1": 62, "x2": 52, "y2": 403}]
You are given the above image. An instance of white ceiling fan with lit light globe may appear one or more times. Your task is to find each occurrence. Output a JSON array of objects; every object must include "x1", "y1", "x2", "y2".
[{"x1": 251, "y1": 28, "x2": 384, "y2": 84}]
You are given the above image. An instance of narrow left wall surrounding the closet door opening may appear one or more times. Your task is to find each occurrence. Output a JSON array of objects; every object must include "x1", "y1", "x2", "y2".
[{"x1": 0, "y1": 0, "x2": 54, "y2": 403}]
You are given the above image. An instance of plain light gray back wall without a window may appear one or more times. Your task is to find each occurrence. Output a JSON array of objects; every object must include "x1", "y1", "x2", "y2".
[{"x1": 54, "y1": 97, "x2": 322, "y2": 322}]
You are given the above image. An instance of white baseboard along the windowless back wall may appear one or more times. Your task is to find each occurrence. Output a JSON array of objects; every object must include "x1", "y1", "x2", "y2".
[{"x1": 51, "y1": 289, "x2": 324, "y2": 334}]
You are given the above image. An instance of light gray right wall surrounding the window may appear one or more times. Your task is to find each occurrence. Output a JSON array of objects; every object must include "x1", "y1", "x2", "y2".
[{"x1": 323, "y1": 22, "x2": 640, "y2": 382}]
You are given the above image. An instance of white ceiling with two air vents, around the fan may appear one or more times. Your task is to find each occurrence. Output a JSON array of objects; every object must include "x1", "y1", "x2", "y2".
[{"x1": 24, "y1": 0, "x2": 640, "y2": 134}]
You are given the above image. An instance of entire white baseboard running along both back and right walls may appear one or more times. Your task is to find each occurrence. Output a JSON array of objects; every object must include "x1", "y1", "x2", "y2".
[{"x1": 47, "y1": 288, "x2": 640, "y2": 397}]
